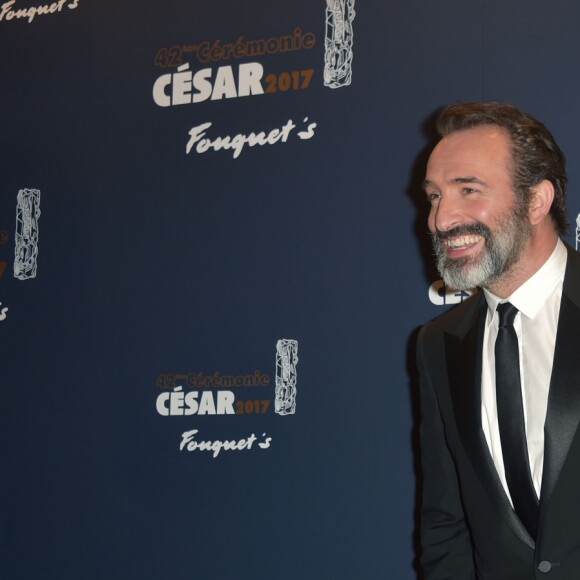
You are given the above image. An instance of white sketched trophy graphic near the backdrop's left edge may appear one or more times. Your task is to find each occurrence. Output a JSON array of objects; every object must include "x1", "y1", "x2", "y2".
[{"x1": 14, "y1": 189, "x2": 40, "y2": 280}]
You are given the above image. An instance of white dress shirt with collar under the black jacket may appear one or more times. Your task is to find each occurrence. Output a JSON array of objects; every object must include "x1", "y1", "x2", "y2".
[{"x1": 481, "y1": 240, "x2": 567, "y2": 501}]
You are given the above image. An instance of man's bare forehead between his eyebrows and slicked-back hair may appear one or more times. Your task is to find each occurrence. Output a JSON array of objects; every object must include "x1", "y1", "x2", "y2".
[{"x1": 426, "y1": 125, "x2": 511, "y2": 181}]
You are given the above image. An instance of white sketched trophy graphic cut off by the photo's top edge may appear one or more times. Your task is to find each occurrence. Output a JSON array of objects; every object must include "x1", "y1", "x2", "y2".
[{"x1": 324, "y1": 0, "x2": 355, "y2": 89}]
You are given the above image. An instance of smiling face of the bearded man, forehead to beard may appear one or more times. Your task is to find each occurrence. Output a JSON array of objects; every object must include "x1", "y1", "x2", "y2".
[{"x1": 424, "y1": 125, "x2": 531, "y2": 290}]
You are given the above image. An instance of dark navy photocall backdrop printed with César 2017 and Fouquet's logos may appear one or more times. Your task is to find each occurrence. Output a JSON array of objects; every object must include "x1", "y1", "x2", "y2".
[{"x1": 0, "y1": 0, "x2": 580, "y2": 580}]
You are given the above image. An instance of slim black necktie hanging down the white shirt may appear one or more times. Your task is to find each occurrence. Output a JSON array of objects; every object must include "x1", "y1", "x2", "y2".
[{"x1": 495, "y1": 302, "x2": 538, "y2": 538}]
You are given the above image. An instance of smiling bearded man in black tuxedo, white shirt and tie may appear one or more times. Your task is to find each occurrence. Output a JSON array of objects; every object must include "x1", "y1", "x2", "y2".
[{"x1": 417, "y1": 102, "x2": 580, "y2": 580}]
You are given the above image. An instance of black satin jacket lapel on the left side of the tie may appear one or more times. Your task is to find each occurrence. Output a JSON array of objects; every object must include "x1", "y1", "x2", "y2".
[{"x1": 444, "y1": 297, "x2": 534, "y2": 548}]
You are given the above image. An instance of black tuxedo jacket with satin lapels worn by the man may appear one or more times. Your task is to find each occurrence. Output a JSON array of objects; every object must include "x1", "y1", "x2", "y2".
[{"x1": 417, "y1": 249, "x2": 580, "y2": 580}]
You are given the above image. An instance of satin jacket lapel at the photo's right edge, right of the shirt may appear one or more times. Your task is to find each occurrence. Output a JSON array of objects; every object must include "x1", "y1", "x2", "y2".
[{"x1": 540, "y1": 251, "x2": 580, "y2": 508}]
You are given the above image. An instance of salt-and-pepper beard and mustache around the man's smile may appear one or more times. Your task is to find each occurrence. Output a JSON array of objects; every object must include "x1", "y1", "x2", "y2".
[{"x1": 432, "y1": 210, "x2": 531, "y2": 290}]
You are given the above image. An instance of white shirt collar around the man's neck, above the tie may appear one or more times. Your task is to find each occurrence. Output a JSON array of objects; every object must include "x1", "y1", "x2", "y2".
[{"x1": 483, "y1": 239, "x2": 568, "y2": 322}]
